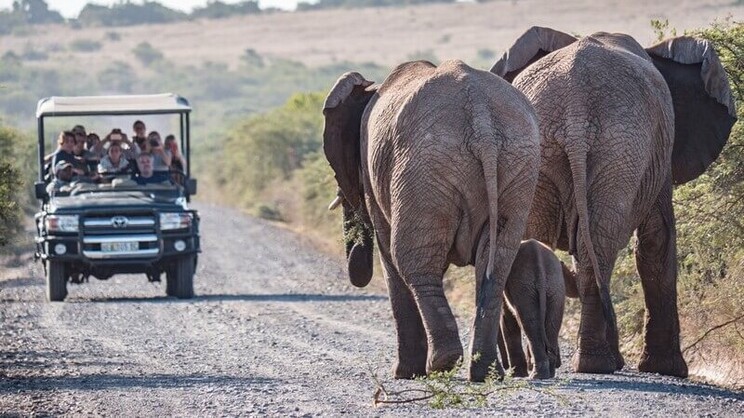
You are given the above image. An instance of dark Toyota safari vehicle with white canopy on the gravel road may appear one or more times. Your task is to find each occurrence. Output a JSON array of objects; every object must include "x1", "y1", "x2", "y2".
[{"x1": 35, "y1": 93, "x2": 200, "y2": 301}]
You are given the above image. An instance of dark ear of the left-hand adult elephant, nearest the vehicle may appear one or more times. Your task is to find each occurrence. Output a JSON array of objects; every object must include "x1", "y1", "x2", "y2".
[{"x1": 323, "y1": 72, "x2": 375, "y2": 208}]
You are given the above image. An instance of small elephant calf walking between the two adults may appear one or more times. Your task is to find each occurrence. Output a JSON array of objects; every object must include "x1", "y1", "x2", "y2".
[{"x1": 501, "y1": 240, "x2": 576, "y2": 379}]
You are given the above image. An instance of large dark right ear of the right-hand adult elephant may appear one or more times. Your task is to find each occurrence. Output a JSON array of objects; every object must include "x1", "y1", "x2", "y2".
[{"x1": 646, "y1": 36, "x2": 736, "y2": 184}]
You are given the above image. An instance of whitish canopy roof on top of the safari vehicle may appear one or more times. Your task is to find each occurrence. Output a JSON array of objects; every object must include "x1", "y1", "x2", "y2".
[{"x1": 36, "y1": 93, "x2": 191, "y2": 118}]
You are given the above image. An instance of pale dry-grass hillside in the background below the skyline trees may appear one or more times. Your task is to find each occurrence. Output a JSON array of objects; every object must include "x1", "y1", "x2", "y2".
[{"x1": 0, "y1": 0, "x2": 744, "y2": 71}]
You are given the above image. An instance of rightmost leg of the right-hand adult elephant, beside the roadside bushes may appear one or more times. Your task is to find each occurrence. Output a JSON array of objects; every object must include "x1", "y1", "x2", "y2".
[{"x1": 635, "y1": 181, "x2": 687, "y2": 377}]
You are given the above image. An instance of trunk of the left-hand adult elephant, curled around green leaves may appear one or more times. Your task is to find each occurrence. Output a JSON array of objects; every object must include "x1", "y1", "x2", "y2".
[{"x1": 344, "y1": 201, "x2": 373, "y2": 287}]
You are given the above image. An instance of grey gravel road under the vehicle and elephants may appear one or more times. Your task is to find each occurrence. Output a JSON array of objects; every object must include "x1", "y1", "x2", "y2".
[{"x1": 0, "y1": 204, "x2": 744, "y2": 417}]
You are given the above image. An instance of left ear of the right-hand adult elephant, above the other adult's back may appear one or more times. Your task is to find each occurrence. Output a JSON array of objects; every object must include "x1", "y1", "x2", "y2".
[{"x1": 491, "y1": 26, "x2": 576, "y2": 83}]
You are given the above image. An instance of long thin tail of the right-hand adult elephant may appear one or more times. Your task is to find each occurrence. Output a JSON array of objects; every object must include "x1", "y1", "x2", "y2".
[{"x1": 568, "y1": 150, "x2": 619, "y2": 354}]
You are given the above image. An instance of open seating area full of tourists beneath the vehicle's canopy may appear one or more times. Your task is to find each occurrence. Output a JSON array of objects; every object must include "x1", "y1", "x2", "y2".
[{"x1": 39, "y1": 113, "x2": 189, "y2": 196}]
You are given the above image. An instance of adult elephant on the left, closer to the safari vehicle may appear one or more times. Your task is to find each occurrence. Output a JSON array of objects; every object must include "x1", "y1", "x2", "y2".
[{"x1": 323, "y1": 61, "x2": 540, "y2": 381}]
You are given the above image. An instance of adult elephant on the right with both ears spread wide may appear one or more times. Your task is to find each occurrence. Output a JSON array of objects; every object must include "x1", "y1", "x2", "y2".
[{"x1": 491, "y1": 28, "x2": 736, "y2": 376}]
